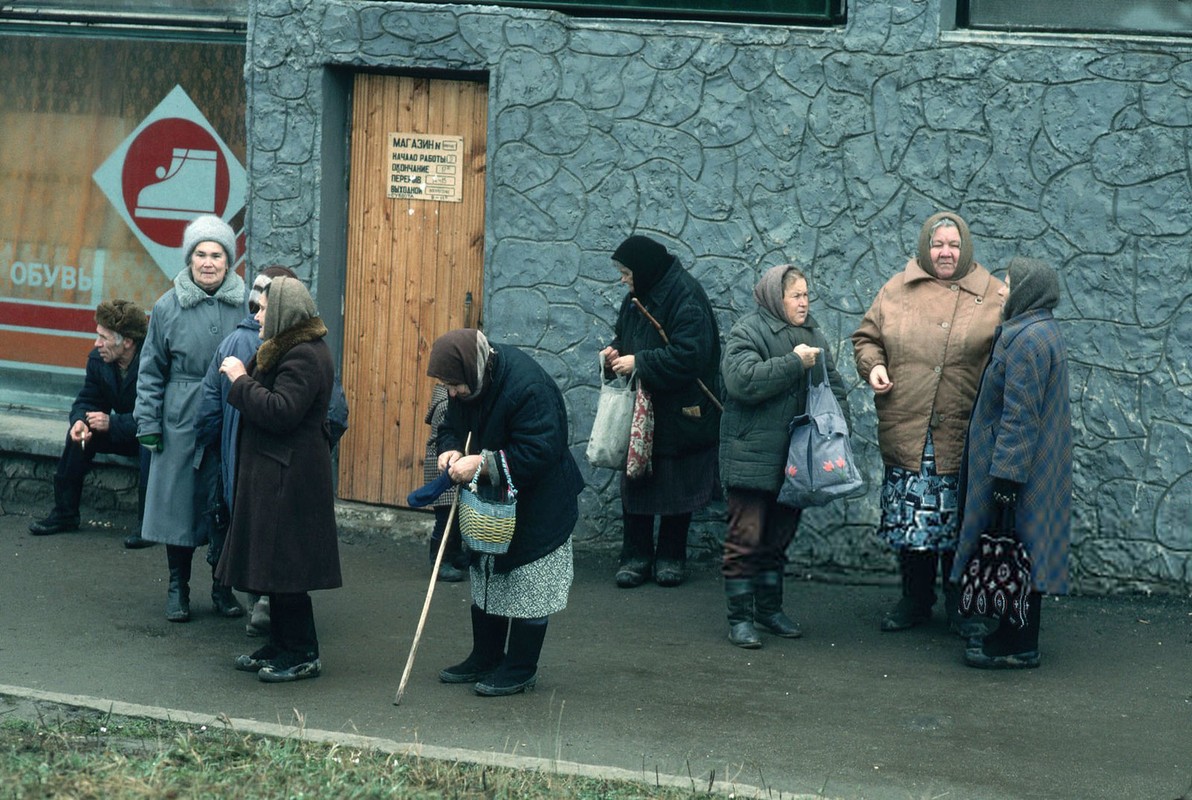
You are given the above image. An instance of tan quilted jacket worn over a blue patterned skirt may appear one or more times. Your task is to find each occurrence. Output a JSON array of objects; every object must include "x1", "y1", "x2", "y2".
[{"x1": 852, "y1": 259, "x2": 1002, "y2": 475}]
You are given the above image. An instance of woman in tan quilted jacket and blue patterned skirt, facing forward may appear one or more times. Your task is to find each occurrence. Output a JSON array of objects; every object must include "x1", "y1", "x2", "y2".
[{"x1": 852, "y1": 211, "x2": 1002, "y2": 637}]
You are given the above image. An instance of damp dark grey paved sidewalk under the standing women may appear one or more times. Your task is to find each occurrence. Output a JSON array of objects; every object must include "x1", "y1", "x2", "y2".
[{"x1": 0, "y1": 513, "x2": 1192, "y2": 800}]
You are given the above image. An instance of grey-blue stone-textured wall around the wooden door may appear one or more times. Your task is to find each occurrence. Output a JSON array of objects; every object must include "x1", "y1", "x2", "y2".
[{"x1": 246, "y1": 0, "x2": 1192, "y2": 593}]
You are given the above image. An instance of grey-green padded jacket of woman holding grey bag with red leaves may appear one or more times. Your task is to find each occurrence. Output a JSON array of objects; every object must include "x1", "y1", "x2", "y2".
[{"x1": 720, "y1": 308, "x2": 849, "y2": 495}]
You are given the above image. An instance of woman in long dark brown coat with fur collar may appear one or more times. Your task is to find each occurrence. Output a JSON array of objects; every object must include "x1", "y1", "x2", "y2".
[{"x1": 216, "y1": 277, "x2": 343, "y2": 683}]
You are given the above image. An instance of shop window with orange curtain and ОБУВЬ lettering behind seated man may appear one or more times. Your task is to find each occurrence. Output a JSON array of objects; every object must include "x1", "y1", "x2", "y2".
[{"x1": 0, "y1": 35, "x2": 246, "y2": 402}]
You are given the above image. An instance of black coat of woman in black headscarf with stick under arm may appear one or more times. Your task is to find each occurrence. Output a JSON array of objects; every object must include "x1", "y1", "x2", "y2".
[{"x1": 613, "y1": 259, "x2": 720, "y2": 457}]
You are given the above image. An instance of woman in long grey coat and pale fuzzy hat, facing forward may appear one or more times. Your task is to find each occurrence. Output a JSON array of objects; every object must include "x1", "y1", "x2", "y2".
[{"x1": 134, "y1": 216, "x2": 244, "y2": 622}]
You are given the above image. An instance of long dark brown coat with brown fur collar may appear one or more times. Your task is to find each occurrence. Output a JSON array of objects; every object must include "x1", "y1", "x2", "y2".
[{"x1": 217, "y1": 317, "x2": 343, "y2": 594}]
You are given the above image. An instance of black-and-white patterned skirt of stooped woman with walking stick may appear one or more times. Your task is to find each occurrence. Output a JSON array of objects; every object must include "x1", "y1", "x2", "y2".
[{"x1": 470, "y1": 537, "x2": 575, "y2": 620}]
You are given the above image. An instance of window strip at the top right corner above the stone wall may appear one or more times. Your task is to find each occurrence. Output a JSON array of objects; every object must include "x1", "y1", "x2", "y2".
[{"x1": 956, "y1": 0, "x2": 1192, "y2": 36}]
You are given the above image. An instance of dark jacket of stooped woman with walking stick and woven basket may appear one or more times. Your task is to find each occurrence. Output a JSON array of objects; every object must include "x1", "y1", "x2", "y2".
[{"x1": 437, "y1": 345, "x2": 584, "y2": 572}]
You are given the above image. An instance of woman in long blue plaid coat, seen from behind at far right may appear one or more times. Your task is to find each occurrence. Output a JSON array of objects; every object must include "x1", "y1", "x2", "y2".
[{"x1": 952, "y1": 259, "x2": 1072, "y2": 669}]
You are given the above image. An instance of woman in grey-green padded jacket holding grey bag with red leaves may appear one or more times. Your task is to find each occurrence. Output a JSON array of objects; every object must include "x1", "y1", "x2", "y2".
[{"x1": 720, "y1": 263, "x2": 849, "y2": 649}]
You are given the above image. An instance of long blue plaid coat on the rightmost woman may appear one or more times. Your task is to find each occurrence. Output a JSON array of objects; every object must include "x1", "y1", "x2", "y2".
[{"x1": 952, "y1": 309, "x2": 1072, "y2": 594}]
